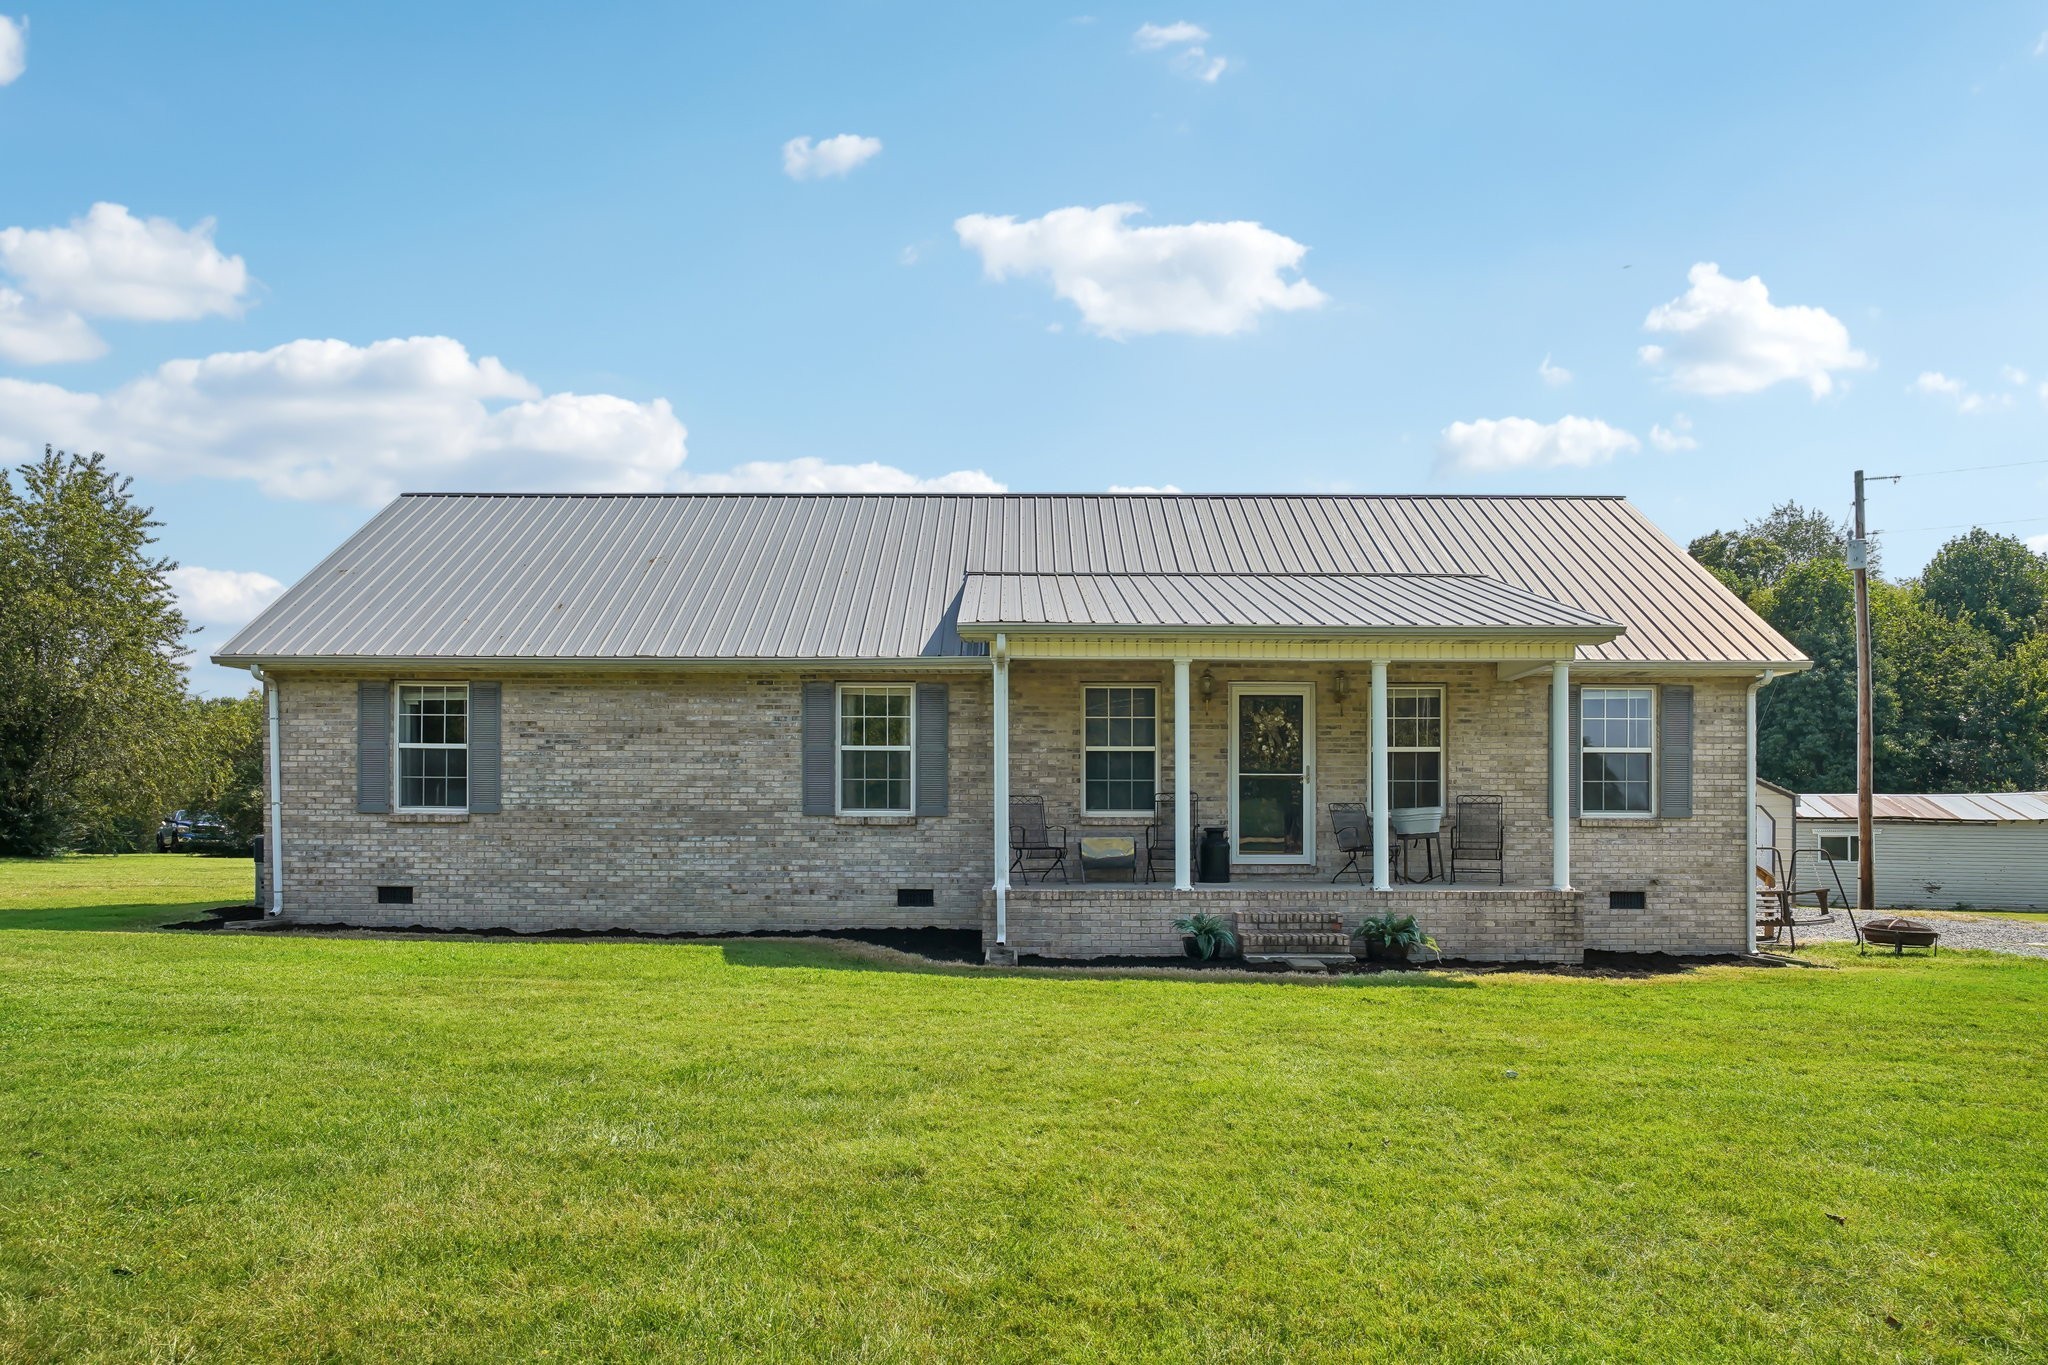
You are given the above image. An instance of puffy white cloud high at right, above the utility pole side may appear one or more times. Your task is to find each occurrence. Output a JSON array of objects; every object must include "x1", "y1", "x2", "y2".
[{"x1": 1638, "y1": 262, "x2": 1870, "y2": 397}]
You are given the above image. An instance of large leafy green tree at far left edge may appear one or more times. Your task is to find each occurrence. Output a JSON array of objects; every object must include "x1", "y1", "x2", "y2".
[{"x1": 0, "y1": 448, "x2": 186, "y2": 855}]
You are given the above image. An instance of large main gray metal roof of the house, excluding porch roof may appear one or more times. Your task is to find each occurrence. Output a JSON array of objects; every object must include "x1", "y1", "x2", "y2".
[{"x1": 215, "y1": 493, "x2": 1804, "y2": 667}]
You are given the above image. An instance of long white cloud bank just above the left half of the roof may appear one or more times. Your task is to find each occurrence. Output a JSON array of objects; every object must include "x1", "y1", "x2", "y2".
[{"x1": 0, "y1": 336, "x2": 1001, "y2": 507}]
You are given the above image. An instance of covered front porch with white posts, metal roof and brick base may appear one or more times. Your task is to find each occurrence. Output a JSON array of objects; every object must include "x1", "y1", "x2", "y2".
[{"x1": 961, "y1": 575, "x2": 1620, "y2": 962}]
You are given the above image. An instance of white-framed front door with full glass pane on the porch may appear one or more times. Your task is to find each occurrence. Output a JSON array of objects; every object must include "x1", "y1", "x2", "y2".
[{"x1": 1231, "y1": 684, "x2": 1315, "y2": 864}]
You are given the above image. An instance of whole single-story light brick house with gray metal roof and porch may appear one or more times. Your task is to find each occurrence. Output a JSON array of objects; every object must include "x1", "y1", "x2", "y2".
[{"x1": 215, "y1": 493, "x2": 1806, "y2": 962}]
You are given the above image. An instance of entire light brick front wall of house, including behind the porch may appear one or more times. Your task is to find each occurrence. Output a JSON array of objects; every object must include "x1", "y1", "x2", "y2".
[{"x1": 264, "y1": 661, "x2": 1747, "y2": 958}]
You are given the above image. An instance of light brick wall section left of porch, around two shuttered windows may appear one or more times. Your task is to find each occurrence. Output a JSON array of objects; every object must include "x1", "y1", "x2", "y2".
[{"x1": 279, "y1": 669, "x2": 991, "y2": 933}]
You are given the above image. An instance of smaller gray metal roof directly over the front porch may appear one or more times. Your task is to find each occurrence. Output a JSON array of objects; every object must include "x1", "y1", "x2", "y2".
[{"x1": 958, "y1": 573, "x2": 1622, "y2": 641}]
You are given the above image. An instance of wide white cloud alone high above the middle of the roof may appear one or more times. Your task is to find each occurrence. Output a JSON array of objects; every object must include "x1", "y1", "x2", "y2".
[{"x1": 952, "y1": 205, "x2": 1325, "y2": 338}]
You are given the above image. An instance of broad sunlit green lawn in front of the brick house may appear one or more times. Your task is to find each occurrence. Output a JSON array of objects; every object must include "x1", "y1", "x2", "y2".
[{"x1": 0, "y1": 864, "x2": 2048, "y2": 1361}]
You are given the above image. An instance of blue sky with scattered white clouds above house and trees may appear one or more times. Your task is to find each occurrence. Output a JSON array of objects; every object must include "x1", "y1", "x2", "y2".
[{"x1": 0, "y1": 0, "x2": 2048, "y2": 688}]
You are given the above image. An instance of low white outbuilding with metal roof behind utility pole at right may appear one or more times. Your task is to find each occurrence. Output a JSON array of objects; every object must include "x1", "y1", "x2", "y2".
[{"x1": 1794, "y1": 792, "x2": 2048, "y2": 911}]
